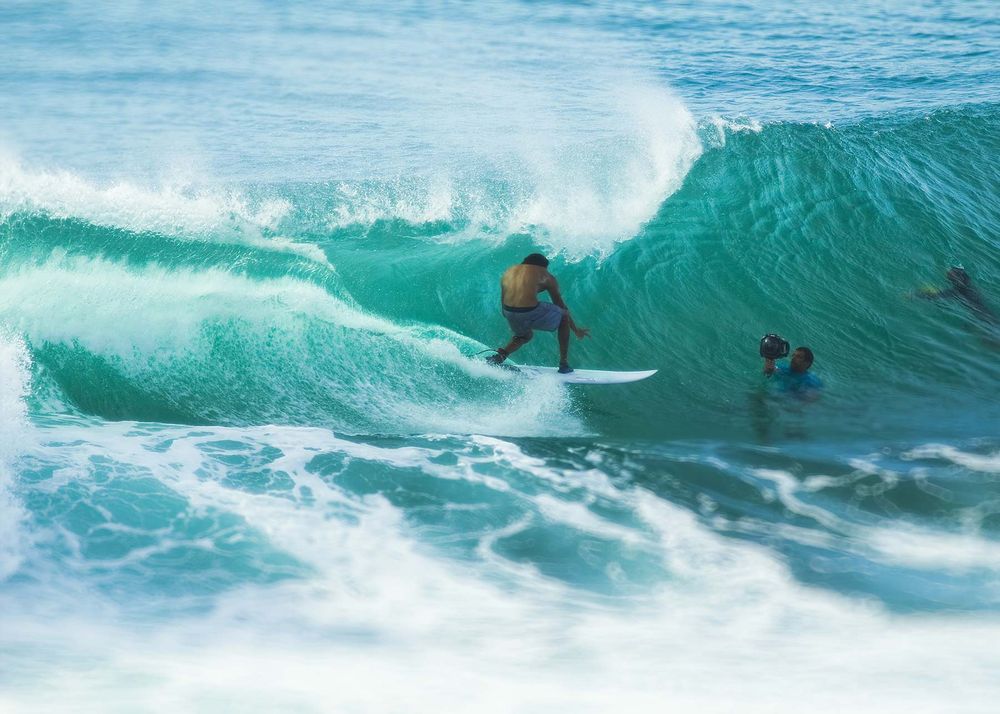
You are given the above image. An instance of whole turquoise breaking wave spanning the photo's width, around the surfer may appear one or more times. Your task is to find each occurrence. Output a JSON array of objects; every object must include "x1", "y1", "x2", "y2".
[{"x1": 0, "y1": 105, "x2": 1000, "y2": 440}]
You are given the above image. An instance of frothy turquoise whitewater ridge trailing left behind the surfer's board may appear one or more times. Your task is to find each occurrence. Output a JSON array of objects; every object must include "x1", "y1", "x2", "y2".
[{"x1": 0, "y1": 256, "x2": 580, "y2": 434}]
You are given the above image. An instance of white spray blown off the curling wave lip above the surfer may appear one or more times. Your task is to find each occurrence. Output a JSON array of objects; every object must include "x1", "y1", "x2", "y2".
[{"x1": 331, "y1": 87, "x2": 701, "y2": 259}]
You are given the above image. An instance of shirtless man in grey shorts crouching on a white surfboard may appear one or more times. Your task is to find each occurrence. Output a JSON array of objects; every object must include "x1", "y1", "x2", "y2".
[{"x1": 488, "y1": 253, "x2": 590, "y2": 374}]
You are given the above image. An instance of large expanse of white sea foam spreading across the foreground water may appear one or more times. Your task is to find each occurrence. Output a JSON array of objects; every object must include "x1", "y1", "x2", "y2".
[{"x1": 7, "y1": 424, "x2": 1000, "y2": 713}]
